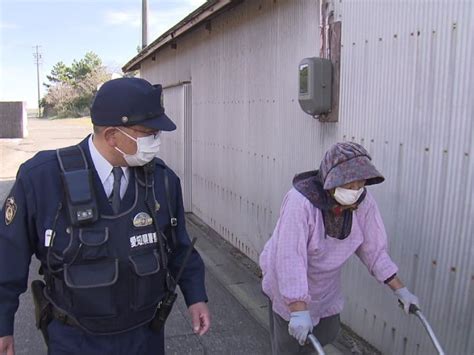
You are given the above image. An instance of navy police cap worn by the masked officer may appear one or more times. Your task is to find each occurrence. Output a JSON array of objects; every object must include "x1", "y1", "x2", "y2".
[{"x1": 91, "y1": 78, "x2": 176, "y2": 131}]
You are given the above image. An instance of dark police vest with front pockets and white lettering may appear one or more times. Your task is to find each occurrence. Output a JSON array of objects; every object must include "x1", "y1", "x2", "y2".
[{"x1": 45, "y1": 146, "x2": 170, "y2": 334}]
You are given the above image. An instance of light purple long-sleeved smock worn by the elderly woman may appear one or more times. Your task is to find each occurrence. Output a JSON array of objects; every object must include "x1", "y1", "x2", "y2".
[{"x1": 260, "y1": 188, "x2": 398, "y2": 325}]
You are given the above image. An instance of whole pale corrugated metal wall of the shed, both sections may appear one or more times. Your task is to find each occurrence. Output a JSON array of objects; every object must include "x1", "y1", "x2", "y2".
[{"x1": 141, "y1": 0, "x2": 474, "y2": 354}]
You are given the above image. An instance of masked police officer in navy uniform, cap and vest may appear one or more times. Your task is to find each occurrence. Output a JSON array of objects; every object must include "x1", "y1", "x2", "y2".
[{"x1": 0, "y1": 78, "x2": 210, "y2": 355}]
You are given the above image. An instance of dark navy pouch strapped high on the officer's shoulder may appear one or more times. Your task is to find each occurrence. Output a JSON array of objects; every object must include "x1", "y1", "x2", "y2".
[{"x1": 56, "y1": 146, "x2": 98, "y2": 227}]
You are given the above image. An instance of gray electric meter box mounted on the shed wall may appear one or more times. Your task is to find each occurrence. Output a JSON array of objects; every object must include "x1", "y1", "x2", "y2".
[{"x1": 298, "y1": 57, "x2": 332, "y2": 116}]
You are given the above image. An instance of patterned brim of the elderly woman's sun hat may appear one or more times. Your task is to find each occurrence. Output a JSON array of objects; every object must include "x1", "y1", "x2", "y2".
[{"x1": 324, "y1": 156, "x2": 385, "y2": 190}]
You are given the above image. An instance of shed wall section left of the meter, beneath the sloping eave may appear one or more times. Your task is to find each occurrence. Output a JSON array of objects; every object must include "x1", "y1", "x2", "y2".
[{"x1": 142, "y1": 1, "x2": 328, "y2": 260}]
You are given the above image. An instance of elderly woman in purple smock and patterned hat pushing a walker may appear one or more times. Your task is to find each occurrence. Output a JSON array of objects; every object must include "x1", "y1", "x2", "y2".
[{"x1": 260, "y1": 142, "x2": 419, "y2": 354}]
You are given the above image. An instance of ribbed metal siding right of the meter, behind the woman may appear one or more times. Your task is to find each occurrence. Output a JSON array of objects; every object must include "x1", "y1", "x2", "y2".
[{"x1": 340, "y1": 1, "x2": 474, "y2": 354}]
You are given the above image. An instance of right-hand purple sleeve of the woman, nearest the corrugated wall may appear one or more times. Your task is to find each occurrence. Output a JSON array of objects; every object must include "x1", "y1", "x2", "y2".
[{"x1": 356, "y1": 193, "x2": 398, "y2": 282}]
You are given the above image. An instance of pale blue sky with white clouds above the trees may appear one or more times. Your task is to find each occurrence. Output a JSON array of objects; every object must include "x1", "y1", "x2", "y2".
[{"x1": 0, "y1": 0, "x2": 205, "y2": 108}]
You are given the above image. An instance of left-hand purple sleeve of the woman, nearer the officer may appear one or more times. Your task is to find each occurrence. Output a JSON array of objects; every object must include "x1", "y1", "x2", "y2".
[{"x1": 276, "y1": 190, "x2": 311, "y2": 304}]
